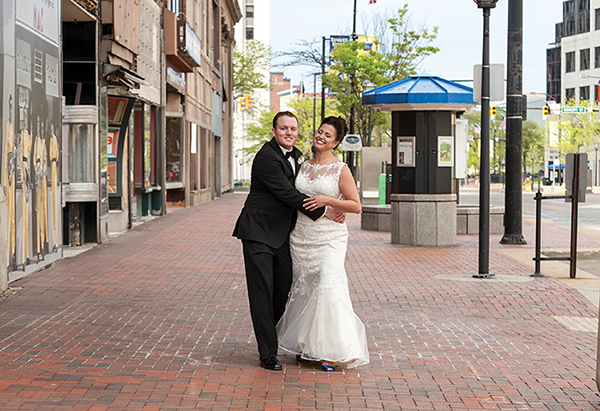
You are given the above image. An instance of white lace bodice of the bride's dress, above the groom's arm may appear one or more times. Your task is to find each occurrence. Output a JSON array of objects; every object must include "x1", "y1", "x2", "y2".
[{"x1": 296, "y1": 161, "x2": 345, "y2": 198}]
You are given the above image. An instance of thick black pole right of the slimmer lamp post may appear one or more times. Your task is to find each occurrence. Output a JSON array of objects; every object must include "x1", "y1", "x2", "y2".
[{"x1": 500, "y1": 0, "x2": 527, "y2": 244}]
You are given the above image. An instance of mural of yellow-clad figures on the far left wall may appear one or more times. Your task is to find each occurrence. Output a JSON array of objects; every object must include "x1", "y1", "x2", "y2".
[{"x1": 0, "y1": 0, "x2": 62, "y2": 281}]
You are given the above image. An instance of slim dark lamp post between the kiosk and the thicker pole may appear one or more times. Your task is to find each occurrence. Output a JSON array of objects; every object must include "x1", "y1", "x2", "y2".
[{"x1": 473, "y1": 0, "x2": 498, "y2": 278}]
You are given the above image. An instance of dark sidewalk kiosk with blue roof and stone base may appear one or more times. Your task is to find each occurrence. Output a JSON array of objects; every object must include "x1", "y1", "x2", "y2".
[{"x1": 362, "y1": 76, "x2": 476, "y2": 245}]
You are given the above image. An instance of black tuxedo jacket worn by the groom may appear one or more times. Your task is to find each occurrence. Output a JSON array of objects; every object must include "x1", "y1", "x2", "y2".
[{"x1": 233, "y1": 138, "x2": 325, "y2": 248}]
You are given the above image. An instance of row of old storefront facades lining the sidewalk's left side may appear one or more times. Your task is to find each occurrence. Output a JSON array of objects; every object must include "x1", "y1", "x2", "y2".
[{"x1": 0, "y1": 0, "x2": 241, "y2": 287}]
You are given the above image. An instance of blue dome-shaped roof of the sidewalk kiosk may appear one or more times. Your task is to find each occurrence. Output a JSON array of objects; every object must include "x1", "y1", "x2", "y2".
[{"x1": 362, "y1": 76, "x2": 477, "y2": 106}]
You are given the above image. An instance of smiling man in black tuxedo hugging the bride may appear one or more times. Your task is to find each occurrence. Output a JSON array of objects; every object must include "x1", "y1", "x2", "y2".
[{"x1": 233, "y1": 111, "x2": 337, "y2": 371}]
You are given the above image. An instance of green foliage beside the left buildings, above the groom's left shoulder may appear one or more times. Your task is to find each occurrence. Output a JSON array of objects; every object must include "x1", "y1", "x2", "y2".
[{"x1": 233, "y1": 40, "x2": 271, "y2": 94}]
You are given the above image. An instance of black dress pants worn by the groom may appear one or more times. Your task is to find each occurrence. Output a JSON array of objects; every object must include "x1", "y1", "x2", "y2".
[{"x1": 242, "y1": 240, "x2": 292, "y2": 360}]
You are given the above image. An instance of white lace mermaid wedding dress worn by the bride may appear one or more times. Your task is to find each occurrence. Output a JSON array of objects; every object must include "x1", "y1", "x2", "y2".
[{"x1": 277, "y1": 161, "x2": 369, "y2": 368}]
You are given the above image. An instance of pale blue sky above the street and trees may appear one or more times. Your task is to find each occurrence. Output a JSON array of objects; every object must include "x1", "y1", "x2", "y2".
[{"x1": 271, "y1": 0, "x2": 563, "y2": 93}]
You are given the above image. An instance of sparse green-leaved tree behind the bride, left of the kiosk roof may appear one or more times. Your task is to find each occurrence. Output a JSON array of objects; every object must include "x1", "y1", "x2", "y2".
[{"x1": 277, "y1": 4, "x2": 439, "y2": 144}]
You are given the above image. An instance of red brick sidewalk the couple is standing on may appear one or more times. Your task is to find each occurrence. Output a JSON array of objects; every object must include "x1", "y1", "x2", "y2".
[{"x1": 0, "y1": 193, "x2": 600, "y2": 411}]
